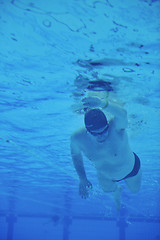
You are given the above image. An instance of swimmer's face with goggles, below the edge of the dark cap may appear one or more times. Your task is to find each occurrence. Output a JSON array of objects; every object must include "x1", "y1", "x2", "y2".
[{"x1": 87, "y1": 125, "x2": 109, "y2": 143}]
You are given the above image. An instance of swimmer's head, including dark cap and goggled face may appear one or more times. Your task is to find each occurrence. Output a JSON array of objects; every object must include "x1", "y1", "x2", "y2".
[{"x1": 84, "y1": 109, "x2": 109, "y2": 139}]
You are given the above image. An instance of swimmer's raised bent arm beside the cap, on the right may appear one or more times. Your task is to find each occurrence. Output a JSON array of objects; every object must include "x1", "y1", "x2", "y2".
[{"x1": 103, "y1": 101, "x2": 128, "y2": 129}]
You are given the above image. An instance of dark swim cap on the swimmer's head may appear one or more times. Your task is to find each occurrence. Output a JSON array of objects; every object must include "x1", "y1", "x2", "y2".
[{"x1": 84, "y1": 109, "x2": 108, "y2": 132}]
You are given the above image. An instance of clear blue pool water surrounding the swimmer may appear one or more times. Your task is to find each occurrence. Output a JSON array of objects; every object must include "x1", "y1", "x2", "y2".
[{"x1": 0, "y1": 0, "x2": 160, "y2": 240}]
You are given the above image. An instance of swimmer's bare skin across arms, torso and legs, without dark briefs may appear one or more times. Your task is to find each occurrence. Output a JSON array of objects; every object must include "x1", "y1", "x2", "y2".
[{"x1": 71, "y1": 103, "x2": 141, "y2": 210}]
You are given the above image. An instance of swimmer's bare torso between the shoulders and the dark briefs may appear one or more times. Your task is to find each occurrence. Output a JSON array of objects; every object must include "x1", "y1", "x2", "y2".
[{"x1": 75, "y1": 125, "x2": 134, "y2": 180}]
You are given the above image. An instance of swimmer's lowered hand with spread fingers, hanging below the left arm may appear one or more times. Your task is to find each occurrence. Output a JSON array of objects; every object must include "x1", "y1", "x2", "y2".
[{"x1": 79, "y1": 179, "x2": 92, "y2": 199}]
